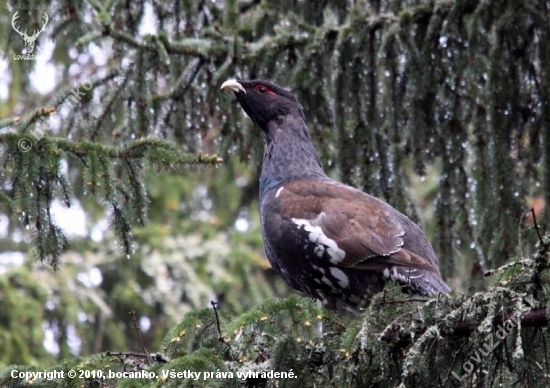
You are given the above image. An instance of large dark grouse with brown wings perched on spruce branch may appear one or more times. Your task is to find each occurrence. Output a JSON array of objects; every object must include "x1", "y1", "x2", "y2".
[{"x1": 221, "y1": 80, "x2": 450, "y2": 311}]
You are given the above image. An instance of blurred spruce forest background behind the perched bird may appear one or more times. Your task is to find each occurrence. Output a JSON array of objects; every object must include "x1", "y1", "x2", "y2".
[{"x1": 0, "y1": 0, "x2": 550, "y2": 386}]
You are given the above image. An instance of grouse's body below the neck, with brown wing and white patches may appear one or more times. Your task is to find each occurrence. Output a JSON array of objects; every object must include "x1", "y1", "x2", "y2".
[{"x1": 261, "y1": 178, "x2": 450, "y2": 310}]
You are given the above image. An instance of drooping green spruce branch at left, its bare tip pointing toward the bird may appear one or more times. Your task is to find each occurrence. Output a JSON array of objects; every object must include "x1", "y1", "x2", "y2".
[{"x1": 0, "y1": 133, "x2": 223, "y2": 269}]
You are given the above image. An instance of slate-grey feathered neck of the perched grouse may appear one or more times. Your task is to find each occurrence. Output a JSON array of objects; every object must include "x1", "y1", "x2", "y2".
[{"x1": 260, "y1": 117, "x2": 327, "y2": 197}]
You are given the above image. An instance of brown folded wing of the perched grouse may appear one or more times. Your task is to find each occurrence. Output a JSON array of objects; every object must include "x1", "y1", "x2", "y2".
[{"x1": 279, "y1": 181, "x2": 435, "y2": 271}]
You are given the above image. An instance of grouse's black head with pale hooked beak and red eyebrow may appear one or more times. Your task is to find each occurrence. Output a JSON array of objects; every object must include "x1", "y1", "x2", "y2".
[{"x1": 221, "y1": 80, "x2": 304, "y2": 134}]
